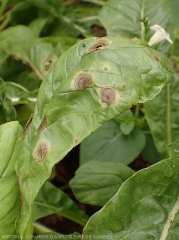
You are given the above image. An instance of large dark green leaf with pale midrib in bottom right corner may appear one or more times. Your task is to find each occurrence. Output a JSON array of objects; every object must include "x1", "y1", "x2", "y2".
[{"x1": 83, "y1": 140, "x2": 179, "y2": 240}]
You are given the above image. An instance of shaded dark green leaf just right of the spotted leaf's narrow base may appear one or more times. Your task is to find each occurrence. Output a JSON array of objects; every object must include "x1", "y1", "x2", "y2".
[{"x1": 33, "y1": 182, "x2": 88, "y2": 226}]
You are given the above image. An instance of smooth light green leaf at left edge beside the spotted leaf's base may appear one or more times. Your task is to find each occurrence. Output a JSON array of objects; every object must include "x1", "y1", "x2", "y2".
[{"x1": 0, "y1": 122, "x2": 22, "y2": 234}]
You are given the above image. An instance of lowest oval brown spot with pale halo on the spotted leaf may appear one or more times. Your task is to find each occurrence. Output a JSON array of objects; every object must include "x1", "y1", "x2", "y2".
[{"x1": 34, "y1": 141, "x2": 49, "y2": 163}]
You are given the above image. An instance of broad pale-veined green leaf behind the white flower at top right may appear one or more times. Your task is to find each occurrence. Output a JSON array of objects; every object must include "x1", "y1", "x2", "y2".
[{"x1": 99, "y1": 0, "x2": 178, "y2": 52}]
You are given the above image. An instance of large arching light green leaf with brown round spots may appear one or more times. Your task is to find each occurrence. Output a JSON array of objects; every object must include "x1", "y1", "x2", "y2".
[{"x1": 0, "y1": 36, "x2": 173, "y2": 238}]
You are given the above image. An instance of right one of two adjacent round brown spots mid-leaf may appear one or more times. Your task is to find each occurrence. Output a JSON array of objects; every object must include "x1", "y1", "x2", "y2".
[{"x1": 101, "y1": 88, "x2": 116, "y2": 105}]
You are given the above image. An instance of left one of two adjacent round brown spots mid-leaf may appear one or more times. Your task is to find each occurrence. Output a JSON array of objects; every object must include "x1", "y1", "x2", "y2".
[{"x1": 75, "y1": 72, "x2": 93, "y2": 90}]
